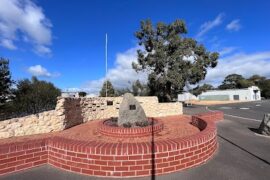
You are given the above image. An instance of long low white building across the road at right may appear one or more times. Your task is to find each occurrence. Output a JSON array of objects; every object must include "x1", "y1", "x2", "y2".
[{"x1": 199, "y1": 86, "x2": 261, "y2": 101}]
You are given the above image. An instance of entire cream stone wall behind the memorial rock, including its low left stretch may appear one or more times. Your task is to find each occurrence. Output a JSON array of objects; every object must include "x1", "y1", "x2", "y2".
[{"x1": 0, "y1": 96, "x2": 182, "y2": 139}]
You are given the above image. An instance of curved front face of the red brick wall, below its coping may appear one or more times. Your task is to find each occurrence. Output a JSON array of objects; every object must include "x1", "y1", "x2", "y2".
[{"x1": 49, "y1": 132, "x2": 217, "y2": 177}]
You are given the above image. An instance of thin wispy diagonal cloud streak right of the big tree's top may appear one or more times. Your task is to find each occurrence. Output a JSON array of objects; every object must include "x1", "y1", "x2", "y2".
[{"x1": 196, "y1": 13, "x2": 225, "y2": 38}]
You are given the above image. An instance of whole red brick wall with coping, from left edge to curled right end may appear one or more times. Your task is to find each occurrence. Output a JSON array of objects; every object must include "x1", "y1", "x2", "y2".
[{"x1": 0, "y1": 112, "x2": 222, "y2": 177}]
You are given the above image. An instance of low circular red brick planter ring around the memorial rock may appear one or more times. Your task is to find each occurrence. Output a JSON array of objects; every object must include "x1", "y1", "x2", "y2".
[{"x1": 98, "y1": 118, "x2": 163, "y2": 137}]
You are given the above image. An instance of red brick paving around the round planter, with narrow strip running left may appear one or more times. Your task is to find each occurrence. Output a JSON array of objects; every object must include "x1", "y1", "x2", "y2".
[{"x1": 0, "y1": 115, "x2": 200, "y2": 145}]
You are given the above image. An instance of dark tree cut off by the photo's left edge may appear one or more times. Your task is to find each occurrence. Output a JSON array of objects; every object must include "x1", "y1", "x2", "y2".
[{"x1": 0, "y1": 58, "x2": 14, "y2": 107}]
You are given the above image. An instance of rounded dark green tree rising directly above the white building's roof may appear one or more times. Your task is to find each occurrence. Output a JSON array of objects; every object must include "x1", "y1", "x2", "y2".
[{"x1": 218, "y1": 74, "x2": 253, "y2": 89}]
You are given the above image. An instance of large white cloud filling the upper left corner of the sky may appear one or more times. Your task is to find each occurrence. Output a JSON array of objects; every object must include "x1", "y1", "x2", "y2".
[{"x1": 0, "y1": 0, "x2": 52, "y2": 54}]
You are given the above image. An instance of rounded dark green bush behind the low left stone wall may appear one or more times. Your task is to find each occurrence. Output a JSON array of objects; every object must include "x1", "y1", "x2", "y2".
[{"x1": 14, "y1": 77, "x2": 61, "y2": 114}]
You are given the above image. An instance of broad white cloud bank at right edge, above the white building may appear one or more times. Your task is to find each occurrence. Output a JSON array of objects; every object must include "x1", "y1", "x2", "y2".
[{"x1": 203, "y1": 51, "x2": 270, "y2": 86}]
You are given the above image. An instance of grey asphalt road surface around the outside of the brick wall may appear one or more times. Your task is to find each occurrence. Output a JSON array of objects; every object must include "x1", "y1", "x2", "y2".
[{"x1": 0, "y1": 101, "x2": 270, "y2": 180}]
